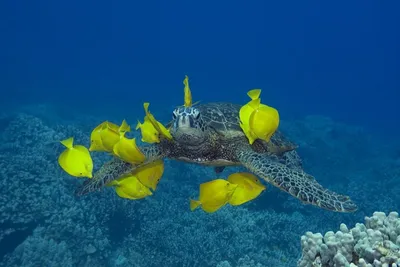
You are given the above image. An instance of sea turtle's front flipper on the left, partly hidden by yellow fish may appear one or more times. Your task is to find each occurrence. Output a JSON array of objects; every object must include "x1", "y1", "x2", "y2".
[{"x1": 75, "y1": 145, "x2": 165, "y2": 196}]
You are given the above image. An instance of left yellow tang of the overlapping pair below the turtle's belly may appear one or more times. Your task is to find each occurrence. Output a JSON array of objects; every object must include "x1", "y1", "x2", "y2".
[{"x1": 190, "y1": 179, "x2": 237, "y2": 213}]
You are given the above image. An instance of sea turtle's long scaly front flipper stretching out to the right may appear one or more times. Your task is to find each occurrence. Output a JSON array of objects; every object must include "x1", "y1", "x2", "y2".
[{"x1": 237, "y1": 149, "x2": 357, "y2": 212}]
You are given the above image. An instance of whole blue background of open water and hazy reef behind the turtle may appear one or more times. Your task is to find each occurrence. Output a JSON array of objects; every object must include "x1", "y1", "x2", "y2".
[{"x1": 0, "y1": 0, "x2": 400, "y2": 267}]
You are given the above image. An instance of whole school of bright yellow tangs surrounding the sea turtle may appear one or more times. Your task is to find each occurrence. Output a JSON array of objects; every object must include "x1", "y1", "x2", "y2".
[{"x1": 58, "y1": 76, "x2": 279, "y2": 213}]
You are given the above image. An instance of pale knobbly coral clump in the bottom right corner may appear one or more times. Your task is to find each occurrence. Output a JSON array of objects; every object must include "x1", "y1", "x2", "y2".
[{"x1": 298, "y1": 212, "x2": 400, "y2": 267}]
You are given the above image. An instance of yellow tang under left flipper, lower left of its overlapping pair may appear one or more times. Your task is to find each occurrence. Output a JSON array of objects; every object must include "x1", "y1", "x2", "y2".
[{"x1": 107, "y1": 174, "x2": 153, "y2": 199}]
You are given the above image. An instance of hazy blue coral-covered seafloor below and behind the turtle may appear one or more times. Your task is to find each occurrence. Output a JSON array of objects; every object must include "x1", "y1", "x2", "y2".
[{"x1": 0, "y1": 105, "x2": 400, "y2": 267}]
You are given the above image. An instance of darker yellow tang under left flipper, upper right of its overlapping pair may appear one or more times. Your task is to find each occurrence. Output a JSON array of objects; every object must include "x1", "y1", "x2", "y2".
[{"x1": 132, "y1": 160, "x2": 164, "y2": 191}]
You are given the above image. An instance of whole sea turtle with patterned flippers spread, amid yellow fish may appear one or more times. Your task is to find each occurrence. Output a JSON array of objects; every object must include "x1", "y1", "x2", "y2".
[{"x1": 76, "y1": 103, "x2": 357, "y2": 212}]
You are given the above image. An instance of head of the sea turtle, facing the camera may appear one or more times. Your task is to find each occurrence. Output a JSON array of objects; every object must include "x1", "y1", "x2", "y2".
[{"x1": 170, "y1": 107, "x2": 206, "y2": 145}]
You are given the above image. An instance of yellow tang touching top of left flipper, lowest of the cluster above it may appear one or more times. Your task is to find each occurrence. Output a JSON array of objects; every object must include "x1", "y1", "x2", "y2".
[{"x1": 113, "y1": 135, "x2": 146, "y2": 164}]
